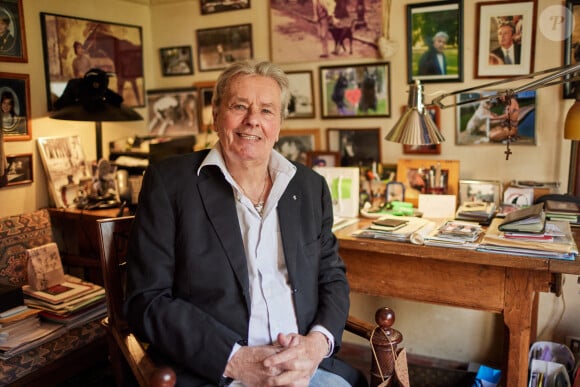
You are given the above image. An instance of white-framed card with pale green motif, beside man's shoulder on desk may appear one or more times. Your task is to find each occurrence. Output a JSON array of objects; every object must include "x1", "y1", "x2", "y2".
[{"x1": 313, "y1": 167, "x2": 360, "y2": 218}]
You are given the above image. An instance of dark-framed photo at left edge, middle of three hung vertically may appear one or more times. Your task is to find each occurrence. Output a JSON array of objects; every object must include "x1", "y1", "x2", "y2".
[{"x1": 0, "y1": 73, "x2": 32, "y2": 141}]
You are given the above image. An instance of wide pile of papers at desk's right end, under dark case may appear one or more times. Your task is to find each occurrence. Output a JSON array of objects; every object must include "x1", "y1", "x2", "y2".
[{"x1": 477, "y1": 219, "x2": 578, "y2": 260}]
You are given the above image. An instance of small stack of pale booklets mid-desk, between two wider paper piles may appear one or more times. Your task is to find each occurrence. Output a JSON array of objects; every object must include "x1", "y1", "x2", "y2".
[{"x1": 425, "y1": 220, "x2": 483, "y2": 250}]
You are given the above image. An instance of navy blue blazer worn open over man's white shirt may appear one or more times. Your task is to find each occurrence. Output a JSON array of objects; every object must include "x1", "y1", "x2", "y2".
[{"x1": 125, "y1": 151, "x2": 364, "y2": 386}]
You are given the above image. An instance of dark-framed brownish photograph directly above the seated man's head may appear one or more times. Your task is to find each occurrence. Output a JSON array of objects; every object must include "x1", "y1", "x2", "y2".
[{"x1": 196, "y1": 24, "x2": 254, "y2": 71}]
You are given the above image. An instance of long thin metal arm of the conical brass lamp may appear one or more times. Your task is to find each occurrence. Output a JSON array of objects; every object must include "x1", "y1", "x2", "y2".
[{"x1": 426, "y1": 63, "x2": 580, "y2": 109}]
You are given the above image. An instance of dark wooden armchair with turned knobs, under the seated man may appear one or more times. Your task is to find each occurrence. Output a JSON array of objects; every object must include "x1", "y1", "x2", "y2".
[{"x1": 97, "y1": 216, "x2": 402, "y2": 387}]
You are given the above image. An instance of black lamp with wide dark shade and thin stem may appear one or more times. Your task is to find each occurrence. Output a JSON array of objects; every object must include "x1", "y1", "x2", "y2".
[{"x1": 50, "y1": 68, "x2": 143, "y2": 160}]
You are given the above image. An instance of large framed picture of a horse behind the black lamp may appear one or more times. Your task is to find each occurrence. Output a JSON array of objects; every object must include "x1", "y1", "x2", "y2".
[{"x1": 40, "y1": 12, "x2": 145, "y2": 110}]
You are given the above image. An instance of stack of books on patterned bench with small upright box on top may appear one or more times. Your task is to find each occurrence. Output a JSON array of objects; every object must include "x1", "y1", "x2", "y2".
[{"x1": 22, "y1": 275, "x2": 107, "y2": 328}]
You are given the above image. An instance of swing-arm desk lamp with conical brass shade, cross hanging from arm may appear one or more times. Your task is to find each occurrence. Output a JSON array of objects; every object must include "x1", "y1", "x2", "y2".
[{"x1": 385, "y1": 64, "x2": 580, "y2": 160}]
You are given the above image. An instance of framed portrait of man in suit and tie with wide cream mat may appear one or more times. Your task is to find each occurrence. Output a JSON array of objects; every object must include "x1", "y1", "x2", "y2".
[{"x1": 475, "y1": 0, "x2": 536, "y2": 78}]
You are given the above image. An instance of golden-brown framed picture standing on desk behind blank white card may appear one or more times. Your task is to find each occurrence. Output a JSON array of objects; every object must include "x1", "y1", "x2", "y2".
[{"x1": 397, "y1": 159, "x2": 459, "y2": 207}]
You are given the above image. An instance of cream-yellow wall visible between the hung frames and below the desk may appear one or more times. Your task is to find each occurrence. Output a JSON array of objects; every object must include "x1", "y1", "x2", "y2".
[{"x1": 0, "y1": 0, "x2": 580, "y2": 362}]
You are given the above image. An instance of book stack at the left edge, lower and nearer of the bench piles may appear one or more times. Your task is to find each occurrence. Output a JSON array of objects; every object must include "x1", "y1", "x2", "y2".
[{"x1": 0, "y1": 305, "x2": 65, "y2": 360}]
